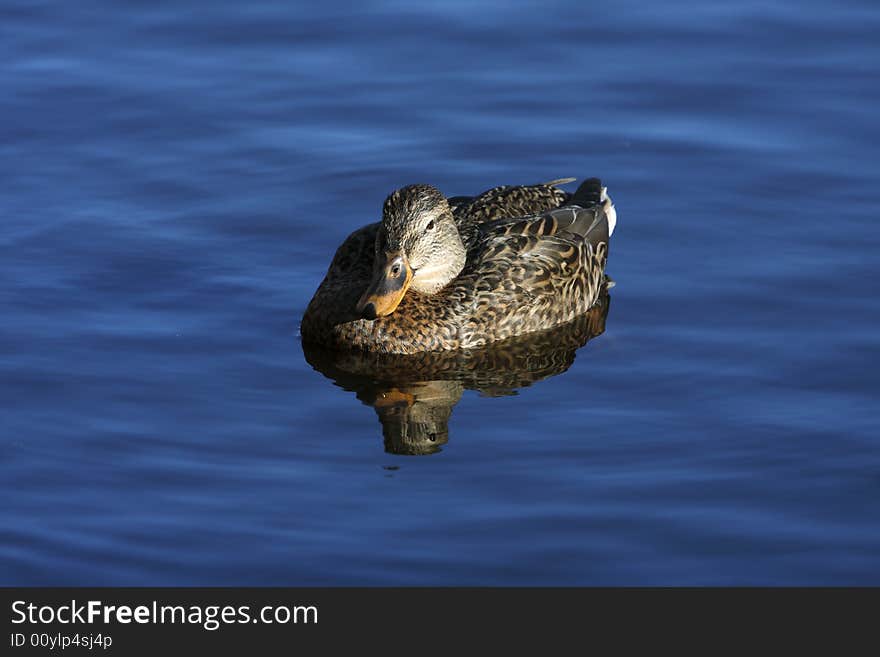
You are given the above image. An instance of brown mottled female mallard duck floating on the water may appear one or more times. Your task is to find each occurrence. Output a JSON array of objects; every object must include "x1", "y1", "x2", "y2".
[{"x1": 301, "y1": 178, "x2": 617, "y2": 354}]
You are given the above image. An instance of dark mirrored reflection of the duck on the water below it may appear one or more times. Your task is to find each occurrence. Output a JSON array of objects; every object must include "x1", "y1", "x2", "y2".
[{"x1": 303, "y1": 294, "x2": 610, "y2": 454}]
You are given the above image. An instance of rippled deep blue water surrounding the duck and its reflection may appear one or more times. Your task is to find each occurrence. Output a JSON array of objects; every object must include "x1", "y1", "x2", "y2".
[{"x1": 0, "y1": 0, "x2": 880, "y2": 585}]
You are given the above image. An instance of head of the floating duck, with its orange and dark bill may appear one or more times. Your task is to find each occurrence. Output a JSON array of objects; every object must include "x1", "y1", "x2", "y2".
[{"x1": 357, "y1": 185, "x2": 466, "y2": 319}]
